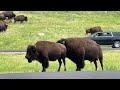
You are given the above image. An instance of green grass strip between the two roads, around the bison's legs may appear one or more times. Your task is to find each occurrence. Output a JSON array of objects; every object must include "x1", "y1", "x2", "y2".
[{"x1": 0, "y1": 51, "x2": 120, "y2": 73}]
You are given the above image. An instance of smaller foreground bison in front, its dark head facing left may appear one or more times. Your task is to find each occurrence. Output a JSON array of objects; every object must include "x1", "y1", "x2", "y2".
[{"x1": 25, "y1": 41, "x2": 66, "y2": 72}]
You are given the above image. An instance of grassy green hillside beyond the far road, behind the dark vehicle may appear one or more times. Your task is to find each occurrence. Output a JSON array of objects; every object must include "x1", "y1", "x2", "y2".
[{"x1": 0, "y1": 11, "x2": 120, "y2": 50}]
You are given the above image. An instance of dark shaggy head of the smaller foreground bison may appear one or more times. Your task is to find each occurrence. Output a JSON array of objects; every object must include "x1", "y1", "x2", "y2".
[{"x1": 25, "y1": 45, "x2": 37, "y2": 63}]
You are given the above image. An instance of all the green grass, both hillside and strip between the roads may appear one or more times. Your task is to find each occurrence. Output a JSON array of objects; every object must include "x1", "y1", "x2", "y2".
[{"x1": 0, "y1": 11, "x2": 120, "y2": 73}]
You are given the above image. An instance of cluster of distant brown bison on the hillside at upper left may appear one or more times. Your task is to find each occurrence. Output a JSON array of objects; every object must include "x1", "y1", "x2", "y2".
[{"x1": 0, "y1": 11, "x2": 28, "y2": 32}]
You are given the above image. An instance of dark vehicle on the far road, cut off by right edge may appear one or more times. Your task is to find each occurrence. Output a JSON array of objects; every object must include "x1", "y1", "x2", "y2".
[{"x1": 87, "y1": 32, "x2": 120, "y2": 48}]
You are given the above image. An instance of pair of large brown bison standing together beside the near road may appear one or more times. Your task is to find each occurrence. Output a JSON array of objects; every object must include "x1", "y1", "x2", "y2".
[{"x1": 25, "y1": 38, "x2": 103, "y2": 72}]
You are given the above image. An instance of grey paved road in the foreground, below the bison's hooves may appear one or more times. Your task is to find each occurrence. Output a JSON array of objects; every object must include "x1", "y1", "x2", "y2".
[{"x1": 0, "y1": 71, "x2": 120, "y2": 79}]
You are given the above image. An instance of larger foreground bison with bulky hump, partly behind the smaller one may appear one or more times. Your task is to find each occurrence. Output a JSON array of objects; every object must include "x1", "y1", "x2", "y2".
[{"x1": 57, "y1": 38, "x2": 103, "y2": 71}]
